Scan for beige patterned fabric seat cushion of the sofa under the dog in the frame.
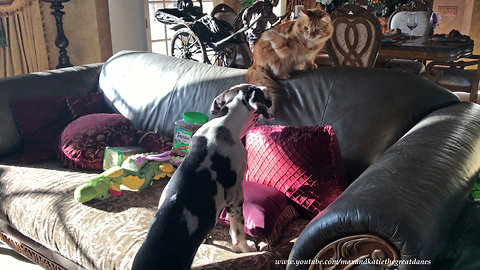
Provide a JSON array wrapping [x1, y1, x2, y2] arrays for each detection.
[[0, 161, 308, 269]]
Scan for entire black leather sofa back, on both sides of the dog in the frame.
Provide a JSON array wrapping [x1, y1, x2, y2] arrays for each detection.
[[100, 51, 458, 182]]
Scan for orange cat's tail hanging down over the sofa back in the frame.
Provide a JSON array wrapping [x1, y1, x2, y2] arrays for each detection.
[[245, 64, 284, 115]]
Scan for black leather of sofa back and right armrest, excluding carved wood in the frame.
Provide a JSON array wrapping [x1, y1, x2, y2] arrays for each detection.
[[100, 52, 480, 269]]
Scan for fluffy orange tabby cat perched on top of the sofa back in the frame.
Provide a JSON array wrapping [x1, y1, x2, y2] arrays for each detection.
[[245, 9, 333, 109]]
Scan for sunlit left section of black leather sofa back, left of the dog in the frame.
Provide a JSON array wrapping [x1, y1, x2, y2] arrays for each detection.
[[100, 51, 245, 136]]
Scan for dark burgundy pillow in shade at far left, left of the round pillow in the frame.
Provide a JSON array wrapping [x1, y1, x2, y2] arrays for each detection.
[[10, 97, 70, 163]]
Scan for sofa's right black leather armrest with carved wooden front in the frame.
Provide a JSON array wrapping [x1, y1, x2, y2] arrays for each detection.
[[287, 103, 480, 269]]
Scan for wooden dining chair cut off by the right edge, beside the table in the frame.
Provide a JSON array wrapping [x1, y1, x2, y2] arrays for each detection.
[[426, 55, 480, 103]]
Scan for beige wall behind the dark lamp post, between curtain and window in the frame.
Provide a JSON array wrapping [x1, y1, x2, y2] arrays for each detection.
[[41, 0, 112, 69]]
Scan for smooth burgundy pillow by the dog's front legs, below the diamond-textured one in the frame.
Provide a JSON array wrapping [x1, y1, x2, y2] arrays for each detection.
[[217, 181, 298, 246]]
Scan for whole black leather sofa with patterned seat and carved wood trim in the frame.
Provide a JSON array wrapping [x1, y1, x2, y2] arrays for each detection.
[[0, 51, 480, 269]]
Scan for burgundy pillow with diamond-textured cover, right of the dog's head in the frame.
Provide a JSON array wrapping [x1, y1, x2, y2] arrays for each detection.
[[245, 126, 346, 218]]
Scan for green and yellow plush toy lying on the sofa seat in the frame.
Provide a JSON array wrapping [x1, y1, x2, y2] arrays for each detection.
[[74, 151, 175, 203]]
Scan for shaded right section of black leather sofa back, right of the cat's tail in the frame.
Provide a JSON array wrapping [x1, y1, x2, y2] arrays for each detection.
[[273, 68, 458, 182]]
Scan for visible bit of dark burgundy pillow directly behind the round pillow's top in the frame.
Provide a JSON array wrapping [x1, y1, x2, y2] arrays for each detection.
[[66, 92, 105, 119]]
